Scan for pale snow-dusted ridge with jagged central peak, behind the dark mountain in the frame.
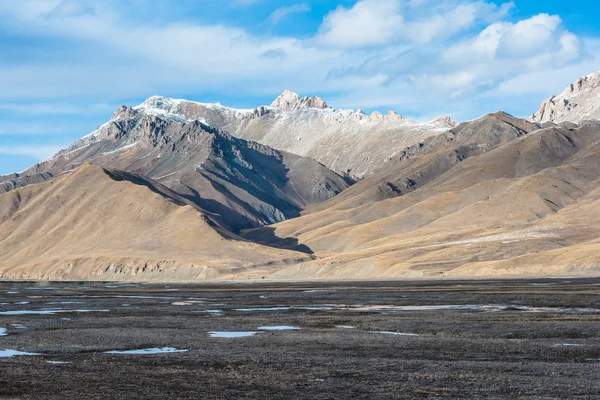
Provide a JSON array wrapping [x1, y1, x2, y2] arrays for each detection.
[[126, 91, 456, 178]]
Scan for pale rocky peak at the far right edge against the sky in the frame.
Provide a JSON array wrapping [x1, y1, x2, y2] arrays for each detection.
[[531, 72, 600, 123]]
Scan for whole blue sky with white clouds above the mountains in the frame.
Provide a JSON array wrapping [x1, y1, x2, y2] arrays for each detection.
[[0, 0, 600, 174]]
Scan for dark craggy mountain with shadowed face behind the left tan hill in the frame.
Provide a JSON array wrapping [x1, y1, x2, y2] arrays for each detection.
[[2, 107, 351, 232]]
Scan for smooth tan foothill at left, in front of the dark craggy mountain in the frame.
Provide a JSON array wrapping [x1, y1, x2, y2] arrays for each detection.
[[0, 164, 310, 281]]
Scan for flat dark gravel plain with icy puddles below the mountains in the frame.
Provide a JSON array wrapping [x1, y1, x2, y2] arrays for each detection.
[[0, 278, 600, 399]]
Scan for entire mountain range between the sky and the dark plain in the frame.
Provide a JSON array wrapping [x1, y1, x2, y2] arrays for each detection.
[[0, 73, 600, 280]]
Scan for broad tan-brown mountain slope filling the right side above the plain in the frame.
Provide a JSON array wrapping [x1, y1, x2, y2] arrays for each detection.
[[247, 114, 600, 279]]
